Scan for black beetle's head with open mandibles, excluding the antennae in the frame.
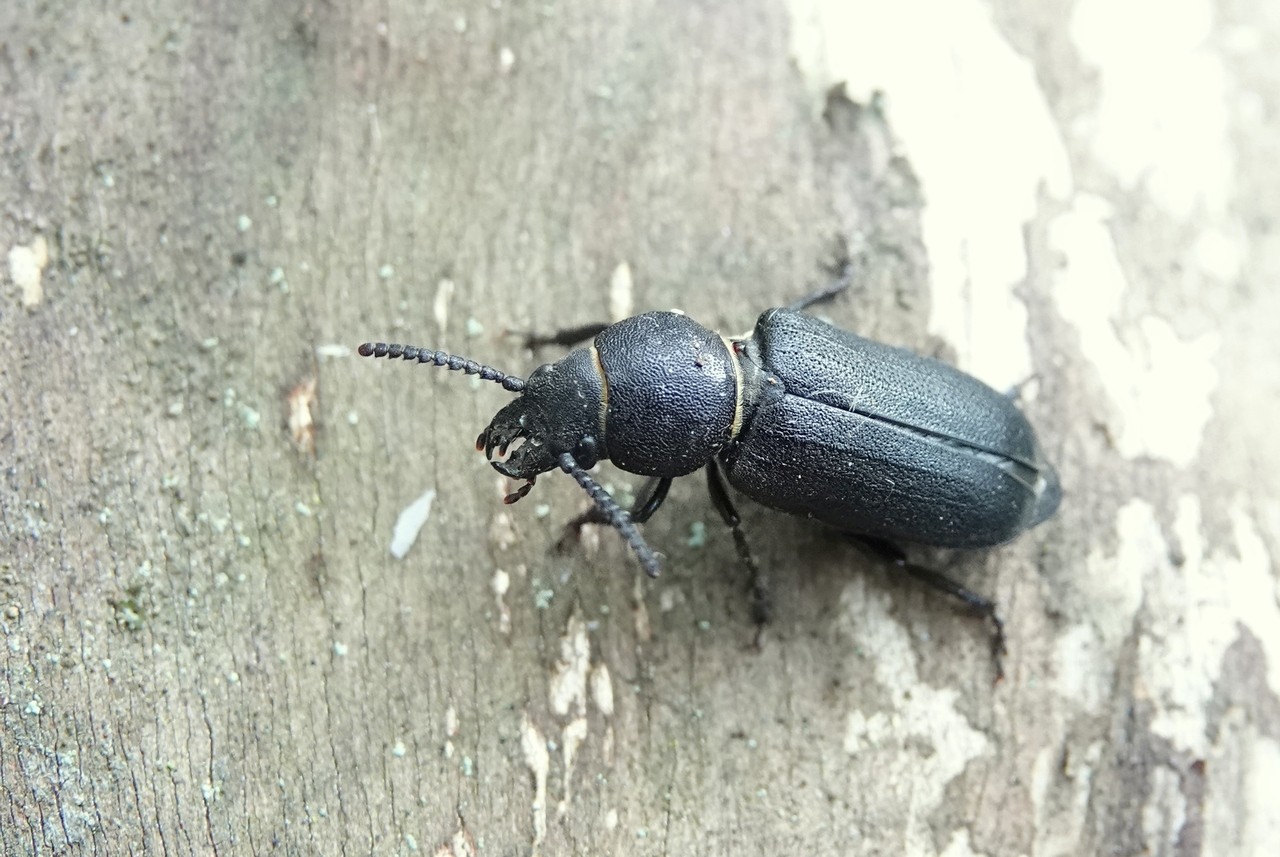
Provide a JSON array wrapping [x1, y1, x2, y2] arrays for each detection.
[[476, 349, 603, 483]]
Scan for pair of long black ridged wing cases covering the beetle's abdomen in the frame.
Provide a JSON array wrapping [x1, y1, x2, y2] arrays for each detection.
[[723, 310, 1061, 547]]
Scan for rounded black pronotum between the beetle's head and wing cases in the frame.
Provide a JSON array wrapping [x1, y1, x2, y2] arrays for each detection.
[[595, 312, 739, 476]]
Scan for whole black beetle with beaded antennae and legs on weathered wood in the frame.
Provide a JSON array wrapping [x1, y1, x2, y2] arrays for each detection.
[[358, 267, 1061, 673]]
